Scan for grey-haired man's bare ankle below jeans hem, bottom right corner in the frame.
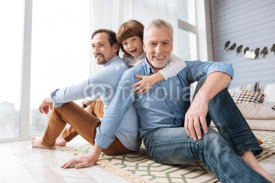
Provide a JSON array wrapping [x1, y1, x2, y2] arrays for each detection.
[[241, 151, 275, 183]]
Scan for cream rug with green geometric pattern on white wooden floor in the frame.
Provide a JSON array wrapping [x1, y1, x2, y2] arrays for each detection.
[[62, 133, 275, 183]]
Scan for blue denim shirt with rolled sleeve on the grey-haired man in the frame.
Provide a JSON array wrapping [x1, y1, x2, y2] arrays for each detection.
[[96, 58, 234, 148]]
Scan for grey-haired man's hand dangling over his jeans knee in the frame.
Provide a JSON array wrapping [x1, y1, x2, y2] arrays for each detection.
[[184, 95, 208, 141]]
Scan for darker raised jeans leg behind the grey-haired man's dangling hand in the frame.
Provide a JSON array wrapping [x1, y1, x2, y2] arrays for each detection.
[[194, 76, 263, 156]]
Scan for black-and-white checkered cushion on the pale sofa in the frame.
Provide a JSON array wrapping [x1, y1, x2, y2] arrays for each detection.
[[229, 90, 265, 104]]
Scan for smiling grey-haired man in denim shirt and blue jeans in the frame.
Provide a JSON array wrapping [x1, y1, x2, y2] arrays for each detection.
[[63, 20, 274, 182]]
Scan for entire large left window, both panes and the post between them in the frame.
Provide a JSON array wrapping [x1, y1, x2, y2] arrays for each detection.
[[0, 0, 91, 142]]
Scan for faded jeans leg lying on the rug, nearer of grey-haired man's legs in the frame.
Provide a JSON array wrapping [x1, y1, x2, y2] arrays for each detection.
[[144, 127, 269, 183]]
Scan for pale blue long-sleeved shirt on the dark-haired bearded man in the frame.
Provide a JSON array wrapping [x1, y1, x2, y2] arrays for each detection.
[[51, 56, 141, 151]]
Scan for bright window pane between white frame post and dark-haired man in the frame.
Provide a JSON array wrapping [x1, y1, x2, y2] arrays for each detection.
[[30, 0, 90, 136]]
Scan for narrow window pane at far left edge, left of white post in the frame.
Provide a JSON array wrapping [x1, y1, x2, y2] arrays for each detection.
[[0, 0, 25, 138]]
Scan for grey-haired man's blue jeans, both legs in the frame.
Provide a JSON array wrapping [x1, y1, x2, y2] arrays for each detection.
[[144, 77, 269, 183]]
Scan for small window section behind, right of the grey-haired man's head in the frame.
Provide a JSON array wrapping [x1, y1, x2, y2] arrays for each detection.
[[178, 0, 198, 61]]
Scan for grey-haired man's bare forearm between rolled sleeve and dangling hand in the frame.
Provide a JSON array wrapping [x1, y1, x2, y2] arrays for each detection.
[[196, 72, 231, 101]]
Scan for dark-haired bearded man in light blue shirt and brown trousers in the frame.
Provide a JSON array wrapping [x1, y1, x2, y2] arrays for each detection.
[[32, 29, 141, 159]]
